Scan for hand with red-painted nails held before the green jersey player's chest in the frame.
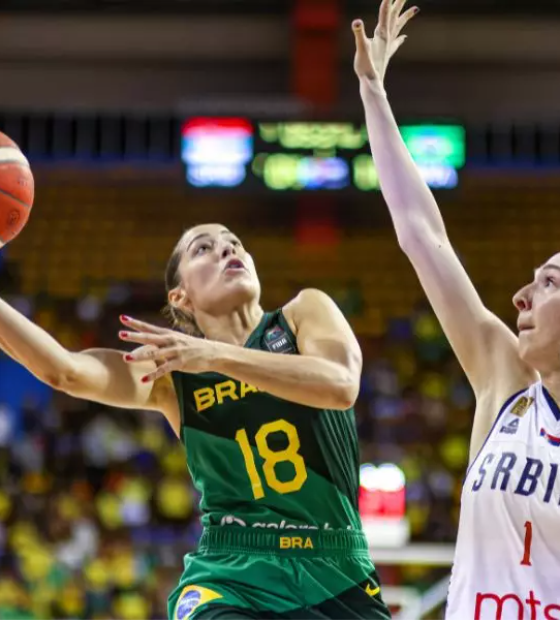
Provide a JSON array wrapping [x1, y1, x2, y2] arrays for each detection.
[[119, 316, 218, 383]]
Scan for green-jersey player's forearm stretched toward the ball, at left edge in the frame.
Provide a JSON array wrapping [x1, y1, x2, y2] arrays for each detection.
[[0, 299, 72, 385]]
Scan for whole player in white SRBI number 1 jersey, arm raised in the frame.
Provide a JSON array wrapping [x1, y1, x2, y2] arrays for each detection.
[[353, 0, 560, 620]]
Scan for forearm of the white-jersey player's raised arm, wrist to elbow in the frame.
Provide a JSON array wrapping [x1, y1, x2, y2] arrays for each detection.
[[360, 78, 446, 246]]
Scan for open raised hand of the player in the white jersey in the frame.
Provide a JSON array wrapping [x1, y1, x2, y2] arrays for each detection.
[[352, 0, 420, 86]]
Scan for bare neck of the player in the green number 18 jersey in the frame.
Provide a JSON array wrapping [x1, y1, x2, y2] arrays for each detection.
[[196, 303, 264, 347]]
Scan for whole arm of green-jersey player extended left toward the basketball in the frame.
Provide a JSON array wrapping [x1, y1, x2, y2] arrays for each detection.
[[0, 299, 179, 432]]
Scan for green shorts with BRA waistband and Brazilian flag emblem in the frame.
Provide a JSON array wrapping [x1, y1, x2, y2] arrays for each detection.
[[168, 526, 391, 620]]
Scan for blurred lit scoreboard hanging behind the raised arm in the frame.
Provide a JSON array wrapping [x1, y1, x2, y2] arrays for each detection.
[[182, 118, 465, 192]]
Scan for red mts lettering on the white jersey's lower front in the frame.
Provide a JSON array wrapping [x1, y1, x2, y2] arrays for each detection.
[[474, 590, 560, 620]]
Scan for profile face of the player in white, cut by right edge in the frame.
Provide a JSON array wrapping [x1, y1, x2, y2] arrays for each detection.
[[513, 254, 560, 372]]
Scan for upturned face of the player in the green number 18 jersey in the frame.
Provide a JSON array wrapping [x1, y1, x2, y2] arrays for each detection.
[[173, 224, 260, 315]]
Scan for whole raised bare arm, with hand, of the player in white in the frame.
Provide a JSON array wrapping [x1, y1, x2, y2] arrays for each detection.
[[353, 0, 536, 450]]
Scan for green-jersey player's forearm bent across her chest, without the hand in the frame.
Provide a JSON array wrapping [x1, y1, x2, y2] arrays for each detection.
[[212, 344, 358, 410]]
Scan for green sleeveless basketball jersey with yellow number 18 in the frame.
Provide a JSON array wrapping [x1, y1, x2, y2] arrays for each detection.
[[173, 310, 361, 530]]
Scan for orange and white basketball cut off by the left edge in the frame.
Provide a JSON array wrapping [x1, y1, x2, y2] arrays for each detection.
[[0, 132, 35, 247]]
